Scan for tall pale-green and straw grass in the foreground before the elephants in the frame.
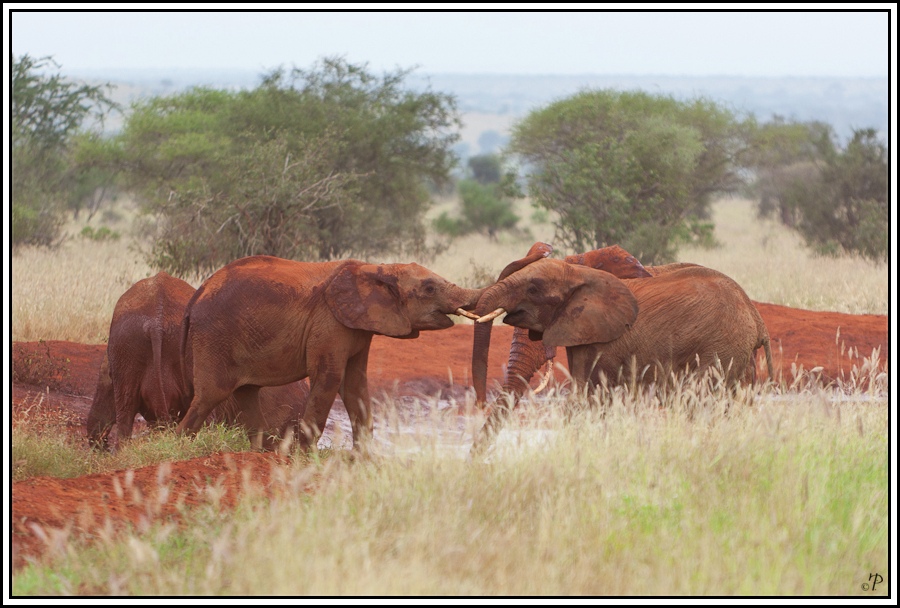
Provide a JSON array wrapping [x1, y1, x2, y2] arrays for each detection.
[[13, 389, 888, 596]]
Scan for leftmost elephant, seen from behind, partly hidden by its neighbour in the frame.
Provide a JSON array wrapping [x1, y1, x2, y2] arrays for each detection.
[[87, 272, 309, 450]]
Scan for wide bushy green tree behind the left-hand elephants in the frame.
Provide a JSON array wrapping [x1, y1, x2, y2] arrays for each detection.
[[90, 59, 459, 275]]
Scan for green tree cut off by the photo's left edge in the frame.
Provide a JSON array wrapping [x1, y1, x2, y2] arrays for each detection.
[[11, 54, 116, 247]]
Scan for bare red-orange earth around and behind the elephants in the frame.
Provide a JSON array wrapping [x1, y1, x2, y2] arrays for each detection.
[[10, 304, 888, 569]]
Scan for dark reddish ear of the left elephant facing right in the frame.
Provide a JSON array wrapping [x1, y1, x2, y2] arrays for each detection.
[[325, 264, 413, 338]]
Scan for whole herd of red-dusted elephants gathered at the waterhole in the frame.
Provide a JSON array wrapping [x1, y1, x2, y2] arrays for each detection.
[[87, 243, 774, 450]]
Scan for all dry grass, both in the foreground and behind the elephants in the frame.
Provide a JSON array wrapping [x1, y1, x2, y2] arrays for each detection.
[[12, 200, 890, 597]]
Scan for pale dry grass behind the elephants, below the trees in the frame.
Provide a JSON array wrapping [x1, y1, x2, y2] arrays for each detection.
[[12, 199, 888, 344]]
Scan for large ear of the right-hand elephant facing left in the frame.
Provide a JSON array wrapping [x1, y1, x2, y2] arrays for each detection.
[[543, 268, 638, 347]]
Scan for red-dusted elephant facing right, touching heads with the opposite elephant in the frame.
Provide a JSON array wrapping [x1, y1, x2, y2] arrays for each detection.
[[177, 255, 482, 449]]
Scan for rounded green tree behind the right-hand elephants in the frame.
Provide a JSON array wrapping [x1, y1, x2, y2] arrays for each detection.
[[509, 90, 742, 263]]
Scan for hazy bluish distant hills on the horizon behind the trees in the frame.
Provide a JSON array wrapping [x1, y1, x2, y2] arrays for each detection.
[[69, 69, 888, 157]]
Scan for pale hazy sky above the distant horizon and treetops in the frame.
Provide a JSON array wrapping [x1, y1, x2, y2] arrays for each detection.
[[4, 3, 896, 76]]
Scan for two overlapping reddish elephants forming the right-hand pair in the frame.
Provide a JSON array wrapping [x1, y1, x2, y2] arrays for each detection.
[[472, 243, 774, 452]]
